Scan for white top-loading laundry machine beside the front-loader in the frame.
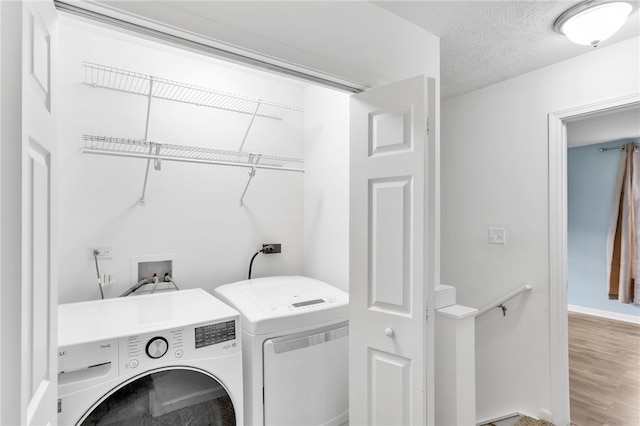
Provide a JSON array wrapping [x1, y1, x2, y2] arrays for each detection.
[[214, 276, 349, 426]]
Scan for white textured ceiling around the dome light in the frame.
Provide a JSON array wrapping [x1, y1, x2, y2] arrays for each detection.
[[374, 0, 640, 98]]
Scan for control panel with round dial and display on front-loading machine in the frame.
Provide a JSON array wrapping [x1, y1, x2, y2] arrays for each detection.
[[119, 319, 240, 374]]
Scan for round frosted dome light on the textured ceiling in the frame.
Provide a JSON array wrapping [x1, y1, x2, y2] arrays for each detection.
[[553, 0, 635, 47]]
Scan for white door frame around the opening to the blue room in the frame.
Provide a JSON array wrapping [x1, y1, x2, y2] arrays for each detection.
[[548, 92, 640, 425]]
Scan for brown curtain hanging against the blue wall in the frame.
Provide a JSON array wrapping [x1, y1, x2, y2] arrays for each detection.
[[607, 143, 640, 305]]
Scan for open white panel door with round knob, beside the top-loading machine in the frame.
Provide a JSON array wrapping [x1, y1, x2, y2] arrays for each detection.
[[349, 77, 437, 425]]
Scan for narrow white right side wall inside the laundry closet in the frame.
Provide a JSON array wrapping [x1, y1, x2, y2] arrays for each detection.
[[304, 87, 349, 291]]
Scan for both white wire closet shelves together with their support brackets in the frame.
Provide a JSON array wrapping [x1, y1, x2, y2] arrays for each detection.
[[82, 62, 304, 206]]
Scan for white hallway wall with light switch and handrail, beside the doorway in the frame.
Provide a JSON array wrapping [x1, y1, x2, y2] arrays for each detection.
[[441, 38, 640, 420]]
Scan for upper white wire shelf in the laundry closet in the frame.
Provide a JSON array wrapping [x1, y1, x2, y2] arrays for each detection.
[[82, 62, 303, 120]]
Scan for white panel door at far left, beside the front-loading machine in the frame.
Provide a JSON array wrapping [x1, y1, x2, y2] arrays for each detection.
[[0, 0, 57, 425]]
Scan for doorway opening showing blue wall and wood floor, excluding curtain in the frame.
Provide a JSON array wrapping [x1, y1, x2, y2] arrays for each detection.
[[567, 108, 640, 426]]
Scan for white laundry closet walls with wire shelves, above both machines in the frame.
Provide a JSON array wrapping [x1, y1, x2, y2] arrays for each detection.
[[57, 16, 349, 303]]
